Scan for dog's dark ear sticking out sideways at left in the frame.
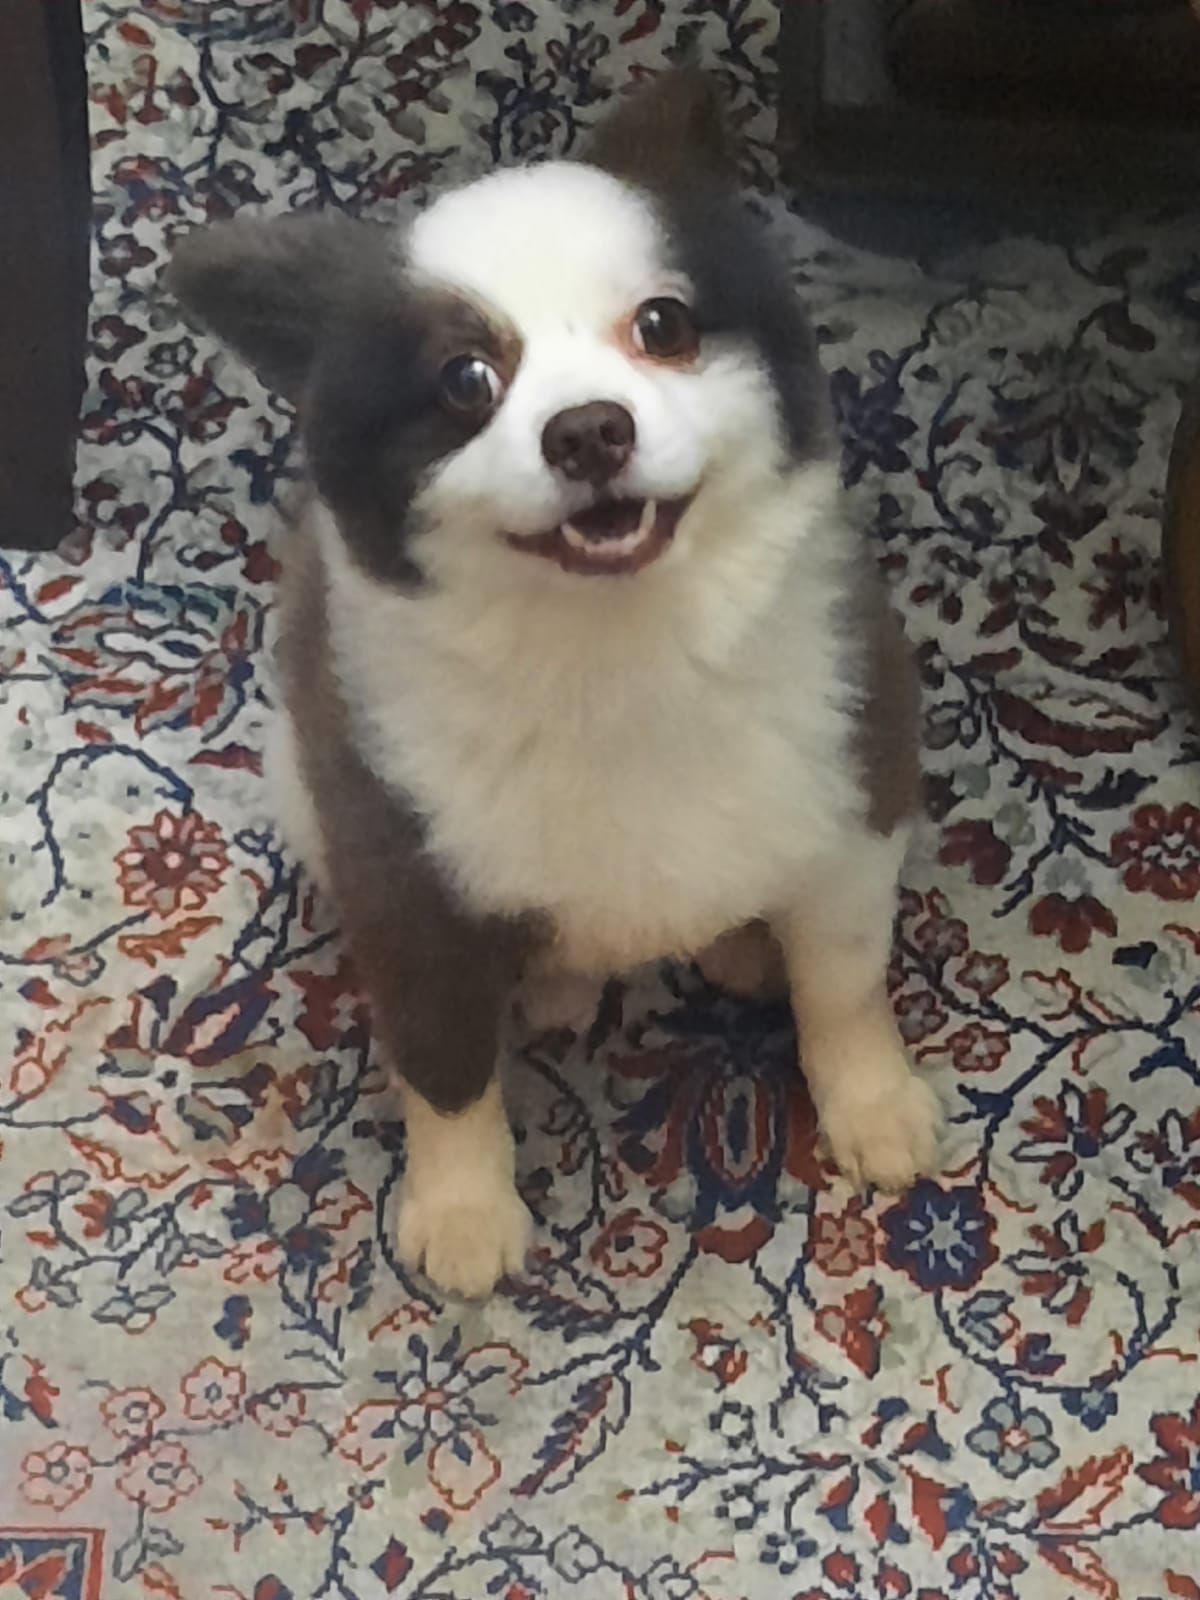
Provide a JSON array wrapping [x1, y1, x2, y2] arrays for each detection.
[[166, 214, 402, 402]]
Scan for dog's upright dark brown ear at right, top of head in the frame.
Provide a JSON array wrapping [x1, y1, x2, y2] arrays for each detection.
[[582, 66, 738, 187]]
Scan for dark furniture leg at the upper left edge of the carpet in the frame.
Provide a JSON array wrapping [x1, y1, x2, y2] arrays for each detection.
[[0, 0, 91, 550]]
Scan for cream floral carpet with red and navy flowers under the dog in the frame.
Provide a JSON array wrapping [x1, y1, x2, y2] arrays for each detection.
[[0, 0, 1200, 1600]]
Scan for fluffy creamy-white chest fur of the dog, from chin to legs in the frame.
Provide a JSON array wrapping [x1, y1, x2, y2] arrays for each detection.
[[322, 470, 861, 971]]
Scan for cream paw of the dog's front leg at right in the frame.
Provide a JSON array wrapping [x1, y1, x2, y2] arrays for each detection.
[[821, 1070, 941, 1192]]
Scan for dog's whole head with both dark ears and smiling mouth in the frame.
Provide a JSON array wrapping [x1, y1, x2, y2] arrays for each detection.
[[171, 74, 829, 587]]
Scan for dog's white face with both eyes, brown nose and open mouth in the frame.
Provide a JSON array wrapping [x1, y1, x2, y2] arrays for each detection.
[[408, 163, 739, 576]]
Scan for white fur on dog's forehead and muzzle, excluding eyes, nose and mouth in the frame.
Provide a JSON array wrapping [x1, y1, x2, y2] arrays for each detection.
[[410, 163, 782, 586]]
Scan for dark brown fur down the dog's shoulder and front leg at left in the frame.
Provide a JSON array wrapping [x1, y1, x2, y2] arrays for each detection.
[[278, 528, 538, 1112]]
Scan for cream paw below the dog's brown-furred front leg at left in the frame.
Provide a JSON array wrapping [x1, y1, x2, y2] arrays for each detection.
[[397, 1179, 533, 1299]]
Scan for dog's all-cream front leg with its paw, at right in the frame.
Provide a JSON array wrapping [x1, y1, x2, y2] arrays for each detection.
[[776, 832, 938, 1189]]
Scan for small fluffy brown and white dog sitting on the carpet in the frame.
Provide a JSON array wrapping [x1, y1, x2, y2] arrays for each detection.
[[173, 72, 936, 1294]]
